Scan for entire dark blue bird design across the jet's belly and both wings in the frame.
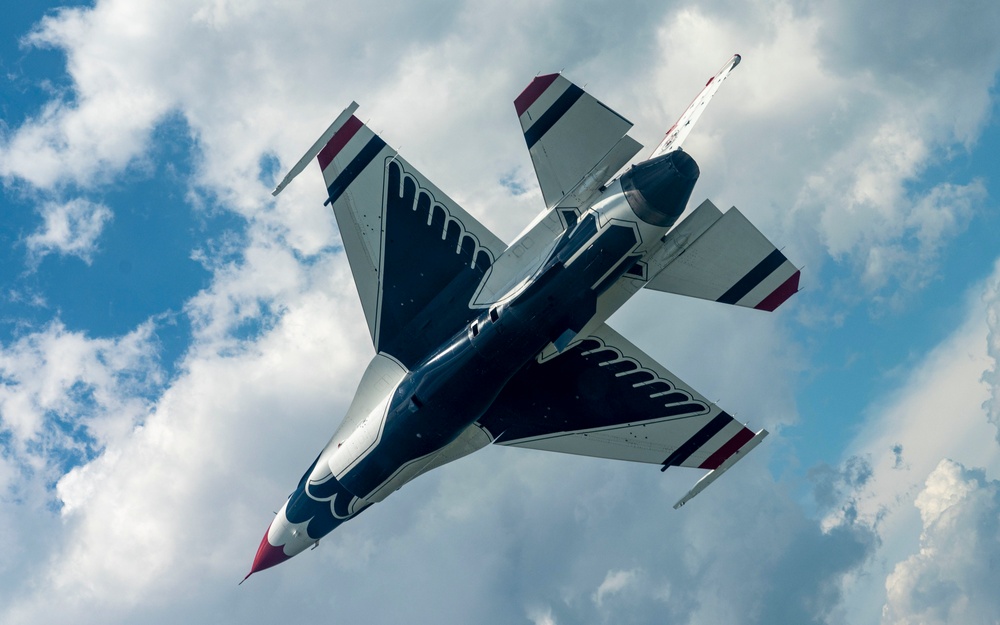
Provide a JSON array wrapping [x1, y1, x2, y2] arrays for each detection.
[[289, 147, 708, 539]]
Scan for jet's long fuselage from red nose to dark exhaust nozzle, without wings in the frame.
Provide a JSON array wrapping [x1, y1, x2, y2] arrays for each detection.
[[251, 151, 698, 572]]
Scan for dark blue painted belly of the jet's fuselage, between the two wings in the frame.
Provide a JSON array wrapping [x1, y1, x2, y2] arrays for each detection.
[[340, 210, 648, 498]]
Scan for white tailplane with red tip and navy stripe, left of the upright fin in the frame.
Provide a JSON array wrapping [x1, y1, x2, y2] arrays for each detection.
[[514, 74, 642, 208]]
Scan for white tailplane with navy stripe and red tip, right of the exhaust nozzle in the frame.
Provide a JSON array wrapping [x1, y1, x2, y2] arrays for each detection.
[[646, 200, 799, 311]]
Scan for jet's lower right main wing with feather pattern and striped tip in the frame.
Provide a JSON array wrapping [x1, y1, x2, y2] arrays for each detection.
[[479, 325, 763, 469]]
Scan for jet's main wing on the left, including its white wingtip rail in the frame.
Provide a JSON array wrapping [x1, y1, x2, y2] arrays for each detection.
[[275, 104, 506, 368]]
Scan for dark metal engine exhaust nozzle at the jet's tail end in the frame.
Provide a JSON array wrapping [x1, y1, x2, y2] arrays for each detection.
[[621, 150, 701, 228]]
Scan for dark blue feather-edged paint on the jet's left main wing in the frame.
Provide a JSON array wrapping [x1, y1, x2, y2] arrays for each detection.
[[376, 161, 492, 369]]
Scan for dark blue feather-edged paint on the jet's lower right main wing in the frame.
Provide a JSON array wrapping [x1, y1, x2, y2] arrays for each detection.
[[479, 338, 709, 443]]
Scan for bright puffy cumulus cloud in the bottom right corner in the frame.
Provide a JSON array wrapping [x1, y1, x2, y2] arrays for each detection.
[[882, 460, 1000, 625]]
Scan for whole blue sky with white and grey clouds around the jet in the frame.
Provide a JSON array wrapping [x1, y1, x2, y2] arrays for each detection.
[[0, 0, 1000, 625]]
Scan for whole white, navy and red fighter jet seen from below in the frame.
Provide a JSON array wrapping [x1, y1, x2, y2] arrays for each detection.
[[244, 55, 799, 579]]
